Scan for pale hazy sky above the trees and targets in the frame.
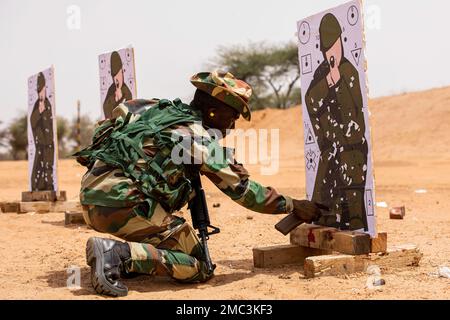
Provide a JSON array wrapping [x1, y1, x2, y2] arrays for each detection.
[[0, 0, 450, 123]]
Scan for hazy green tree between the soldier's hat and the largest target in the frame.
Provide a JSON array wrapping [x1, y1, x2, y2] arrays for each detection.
[[212, 42, 301, 109]]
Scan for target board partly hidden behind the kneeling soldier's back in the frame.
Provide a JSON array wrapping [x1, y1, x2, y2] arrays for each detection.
[[98, 47, 137, 119]]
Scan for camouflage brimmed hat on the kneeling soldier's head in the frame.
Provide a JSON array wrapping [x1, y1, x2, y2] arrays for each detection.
[[191, 71, 252, 121]]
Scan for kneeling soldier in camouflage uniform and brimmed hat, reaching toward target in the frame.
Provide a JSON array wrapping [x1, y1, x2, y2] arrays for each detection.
[[76, 72, 321, 296]]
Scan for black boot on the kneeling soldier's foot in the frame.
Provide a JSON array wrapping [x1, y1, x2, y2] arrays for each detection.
[[86, 238, 131, 297]]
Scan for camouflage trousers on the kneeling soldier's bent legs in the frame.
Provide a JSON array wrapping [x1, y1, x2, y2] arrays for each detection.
[[83, 203, 212, 283]]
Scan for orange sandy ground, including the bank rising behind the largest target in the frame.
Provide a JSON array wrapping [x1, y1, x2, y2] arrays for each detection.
[[0, 88, 450, 300]]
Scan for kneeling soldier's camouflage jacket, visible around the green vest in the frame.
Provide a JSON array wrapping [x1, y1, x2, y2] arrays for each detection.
[[80, 104, 293, 216]]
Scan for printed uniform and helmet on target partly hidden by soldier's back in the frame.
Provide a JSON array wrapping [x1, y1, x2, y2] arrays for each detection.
[[103, 51, 133, 119]]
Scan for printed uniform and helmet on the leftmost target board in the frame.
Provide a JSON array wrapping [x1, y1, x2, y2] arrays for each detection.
[[30, 73, 55, 191]]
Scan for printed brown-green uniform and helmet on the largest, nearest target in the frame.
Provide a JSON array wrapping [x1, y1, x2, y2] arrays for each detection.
[[305, 14, 368, 231]]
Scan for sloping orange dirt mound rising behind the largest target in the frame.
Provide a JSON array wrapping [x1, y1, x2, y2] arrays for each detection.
[[238, 87, 450, 161]]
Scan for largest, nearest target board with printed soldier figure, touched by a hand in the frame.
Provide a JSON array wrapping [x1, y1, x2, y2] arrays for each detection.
[[298, 1, 376, 235]]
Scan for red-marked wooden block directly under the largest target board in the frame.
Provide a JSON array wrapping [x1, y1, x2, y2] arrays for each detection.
[[291, 224, 371, 255]]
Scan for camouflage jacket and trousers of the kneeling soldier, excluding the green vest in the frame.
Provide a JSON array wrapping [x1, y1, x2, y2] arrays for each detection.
[[80, 72, 293, 282]]
